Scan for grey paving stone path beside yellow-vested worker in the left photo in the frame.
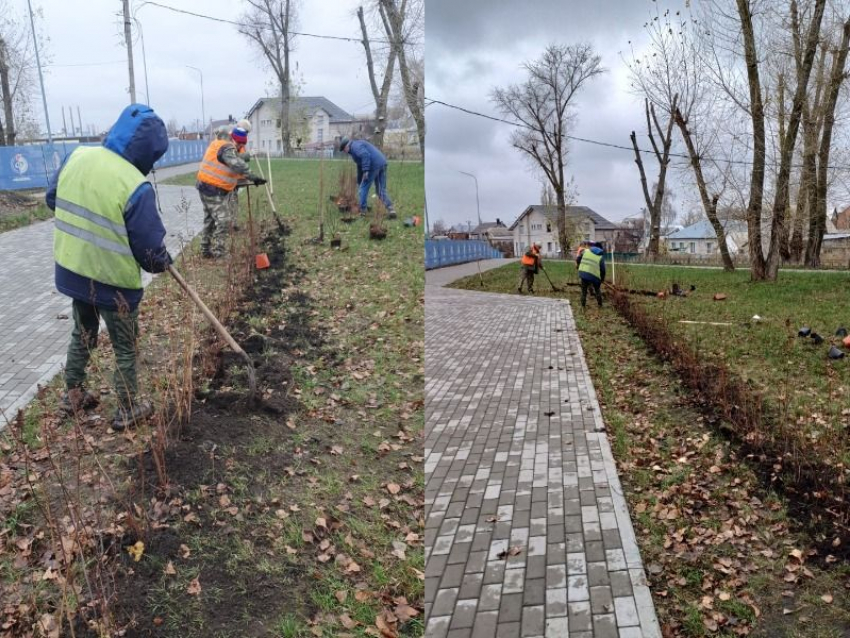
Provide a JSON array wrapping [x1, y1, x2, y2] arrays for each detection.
[[0, 164, 203, 429]]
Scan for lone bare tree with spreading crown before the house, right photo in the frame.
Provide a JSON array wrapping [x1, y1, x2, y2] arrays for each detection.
[[491, 43, 605, 256]]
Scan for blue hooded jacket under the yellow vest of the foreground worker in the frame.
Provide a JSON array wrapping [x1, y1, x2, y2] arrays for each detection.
[[45, 104, 171, 310]]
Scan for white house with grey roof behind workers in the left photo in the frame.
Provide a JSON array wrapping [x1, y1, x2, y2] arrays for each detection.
[[245, 97, 366, 155]]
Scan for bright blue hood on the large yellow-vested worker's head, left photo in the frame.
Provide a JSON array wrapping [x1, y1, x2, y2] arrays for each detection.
[[103, 104, 168, 175]]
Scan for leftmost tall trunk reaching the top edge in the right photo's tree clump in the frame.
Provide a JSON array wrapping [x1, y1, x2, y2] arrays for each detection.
[[736, 0, 766, 281]]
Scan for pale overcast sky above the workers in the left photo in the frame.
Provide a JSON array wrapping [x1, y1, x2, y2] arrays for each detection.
[[19, 0, 374, 133]]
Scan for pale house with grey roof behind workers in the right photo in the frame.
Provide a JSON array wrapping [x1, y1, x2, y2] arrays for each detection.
[[508, 204, 621, 257]]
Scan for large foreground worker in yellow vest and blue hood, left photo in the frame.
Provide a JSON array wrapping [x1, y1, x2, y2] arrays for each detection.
[[46, 104, 171, 430]]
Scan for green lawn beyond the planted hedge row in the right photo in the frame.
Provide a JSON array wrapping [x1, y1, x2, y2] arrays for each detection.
[[454, 261, 850, 450]]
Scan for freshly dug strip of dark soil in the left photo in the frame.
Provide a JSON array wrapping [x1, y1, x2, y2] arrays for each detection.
[[107, 228, 330, 638]]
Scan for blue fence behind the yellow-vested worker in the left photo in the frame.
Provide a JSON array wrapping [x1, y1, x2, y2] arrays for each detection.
[[0, 140, 207, 191]]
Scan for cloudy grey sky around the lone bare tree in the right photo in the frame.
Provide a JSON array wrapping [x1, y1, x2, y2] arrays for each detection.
[[425, 0, 679, 230]]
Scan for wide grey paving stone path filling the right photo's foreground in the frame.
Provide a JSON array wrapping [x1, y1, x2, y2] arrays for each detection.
[[425, 261, 661, 638]]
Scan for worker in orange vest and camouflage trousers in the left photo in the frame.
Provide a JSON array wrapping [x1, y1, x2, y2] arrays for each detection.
[[197, 126, 266, 259]]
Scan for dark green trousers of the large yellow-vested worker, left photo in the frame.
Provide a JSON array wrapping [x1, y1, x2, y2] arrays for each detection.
[[65, 299, 139, 407]]
